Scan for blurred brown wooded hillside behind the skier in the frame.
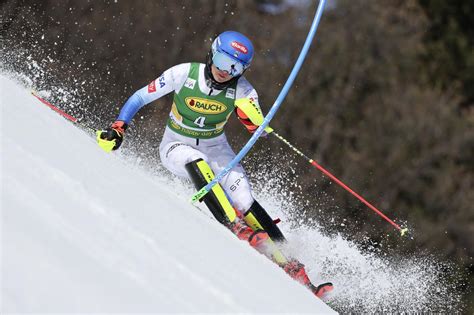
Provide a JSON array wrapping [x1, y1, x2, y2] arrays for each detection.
[[0, 0, 474, 313]]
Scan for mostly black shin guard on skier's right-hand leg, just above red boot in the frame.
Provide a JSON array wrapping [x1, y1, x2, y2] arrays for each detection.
[[244, 200, 286, 242]]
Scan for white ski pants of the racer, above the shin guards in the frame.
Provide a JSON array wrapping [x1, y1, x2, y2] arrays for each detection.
[[160, 127, 254, 212]]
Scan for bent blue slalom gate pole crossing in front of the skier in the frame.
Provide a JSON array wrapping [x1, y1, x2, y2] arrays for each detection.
[[191, 0, 326, 202]]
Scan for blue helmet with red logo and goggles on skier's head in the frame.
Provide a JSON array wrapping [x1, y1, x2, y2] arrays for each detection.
[[206, 31, 254, 88]]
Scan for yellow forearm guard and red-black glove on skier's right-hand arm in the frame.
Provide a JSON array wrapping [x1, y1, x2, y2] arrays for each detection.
[[235, 98, 273, 137]]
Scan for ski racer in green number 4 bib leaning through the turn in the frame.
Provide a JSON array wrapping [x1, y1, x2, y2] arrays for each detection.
[[97, 31, 332, 297]]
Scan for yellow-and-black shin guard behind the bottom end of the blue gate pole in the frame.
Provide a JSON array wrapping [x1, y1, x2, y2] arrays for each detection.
[[185, 159, 237, 226]]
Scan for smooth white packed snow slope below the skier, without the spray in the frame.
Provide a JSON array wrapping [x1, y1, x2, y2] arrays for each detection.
[[0, 76, 334, 314]]
